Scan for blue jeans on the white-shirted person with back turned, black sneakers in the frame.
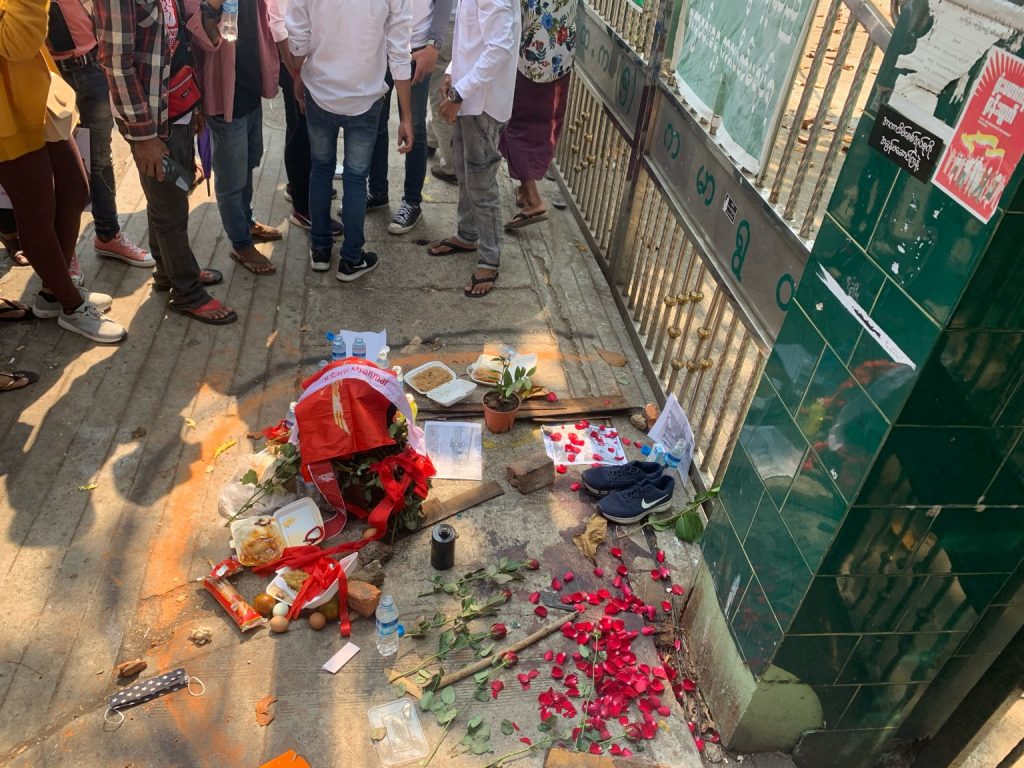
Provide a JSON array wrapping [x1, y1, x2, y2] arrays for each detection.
[[306, 88, 381, 264]]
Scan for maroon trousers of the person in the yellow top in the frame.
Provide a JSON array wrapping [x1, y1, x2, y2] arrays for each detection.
[[0, 141, 89, 312]]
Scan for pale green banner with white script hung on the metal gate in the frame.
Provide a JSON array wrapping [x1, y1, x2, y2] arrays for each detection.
[[676, 0, 815, 172]]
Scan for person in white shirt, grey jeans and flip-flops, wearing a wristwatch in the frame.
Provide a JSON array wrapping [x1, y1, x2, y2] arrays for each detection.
[[428, 0, 522, 298]]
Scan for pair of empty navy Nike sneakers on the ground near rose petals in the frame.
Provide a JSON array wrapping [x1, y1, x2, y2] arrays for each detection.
[[583, 462, 676, 525]]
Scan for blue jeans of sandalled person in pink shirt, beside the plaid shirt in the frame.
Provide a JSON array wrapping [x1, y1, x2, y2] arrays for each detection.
[[206, 104, 263, 250]]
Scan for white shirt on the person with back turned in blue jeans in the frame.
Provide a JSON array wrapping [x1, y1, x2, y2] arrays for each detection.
[[285, 0, 413, 116]]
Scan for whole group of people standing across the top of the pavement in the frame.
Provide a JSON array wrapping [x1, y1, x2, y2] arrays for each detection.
[[0, 0, 575, 391]]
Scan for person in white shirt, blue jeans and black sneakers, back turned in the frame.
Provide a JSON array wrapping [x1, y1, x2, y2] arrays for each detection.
[[285, 0, 413, 283]]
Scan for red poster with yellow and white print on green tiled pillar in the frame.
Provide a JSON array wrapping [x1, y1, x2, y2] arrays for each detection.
[[932, 48, 1024, 222]]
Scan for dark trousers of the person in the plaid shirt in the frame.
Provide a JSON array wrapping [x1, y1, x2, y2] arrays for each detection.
[[138, 123, 210, 309]]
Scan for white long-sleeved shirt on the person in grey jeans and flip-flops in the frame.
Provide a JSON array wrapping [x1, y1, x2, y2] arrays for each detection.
[[447, 0, 522, 123]]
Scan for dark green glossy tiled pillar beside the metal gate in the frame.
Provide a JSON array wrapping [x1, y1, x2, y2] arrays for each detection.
[[703, 4, 1024, 768]]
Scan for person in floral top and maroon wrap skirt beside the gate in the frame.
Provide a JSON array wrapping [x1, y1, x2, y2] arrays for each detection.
[[499, 0, 577, 229]]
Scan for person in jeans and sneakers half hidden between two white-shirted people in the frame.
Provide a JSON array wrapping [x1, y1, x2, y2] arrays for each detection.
[[367, 0, 453, 234]]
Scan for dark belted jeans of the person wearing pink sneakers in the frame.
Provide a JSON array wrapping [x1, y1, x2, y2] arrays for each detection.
[[60, 59, 121, 241]]
